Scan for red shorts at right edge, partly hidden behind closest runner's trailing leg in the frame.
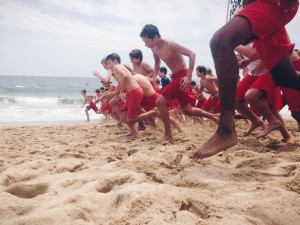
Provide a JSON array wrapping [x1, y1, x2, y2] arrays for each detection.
[[280, 59, 300, 112]]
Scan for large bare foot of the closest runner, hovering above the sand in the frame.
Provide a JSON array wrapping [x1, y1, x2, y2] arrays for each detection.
[[190, 130, 238, 160]]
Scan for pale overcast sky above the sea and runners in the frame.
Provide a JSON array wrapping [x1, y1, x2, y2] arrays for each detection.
[[0, 0, 300, 77]]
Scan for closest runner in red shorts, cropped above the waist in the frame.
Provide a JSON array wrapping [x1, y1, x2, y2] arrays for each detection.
[[191, 0, 300, 159]]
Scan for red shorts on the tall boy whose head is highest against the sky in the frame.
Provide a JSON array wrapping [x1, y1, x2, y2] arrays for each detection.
[[161, 68, 193, 108]]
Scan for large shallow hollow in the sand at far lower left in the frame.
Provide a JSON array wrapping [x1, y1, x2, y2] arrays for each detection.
[[4, 183, 49, 198]]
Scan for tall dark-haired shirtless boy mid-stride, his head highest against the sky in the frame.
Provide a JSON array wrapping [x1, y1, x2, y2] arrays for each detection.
[[140, 24, 218, 140]]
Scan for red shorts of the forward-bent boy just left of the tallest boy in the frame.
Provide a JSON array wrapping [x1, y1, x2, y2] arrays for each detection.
[[123, 87, 144, 119]]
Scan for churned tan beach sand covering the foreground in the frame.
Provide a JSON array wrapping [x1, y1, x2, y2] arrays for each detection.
[[0, 119, 300, 225]]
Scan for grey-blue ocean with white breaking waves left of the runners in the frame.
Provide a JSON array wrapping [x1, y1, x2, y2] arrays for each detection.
[[0, 76, 102, 124]]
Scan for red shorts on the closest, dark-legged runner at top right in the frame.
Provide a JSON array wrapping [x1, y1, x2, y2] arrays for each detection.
[[238, 0, 299, 71]]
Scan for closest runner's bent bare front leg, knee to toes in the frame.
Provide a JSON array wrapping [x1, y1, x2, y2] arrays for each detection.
[[191, 16, 254, 159]]
